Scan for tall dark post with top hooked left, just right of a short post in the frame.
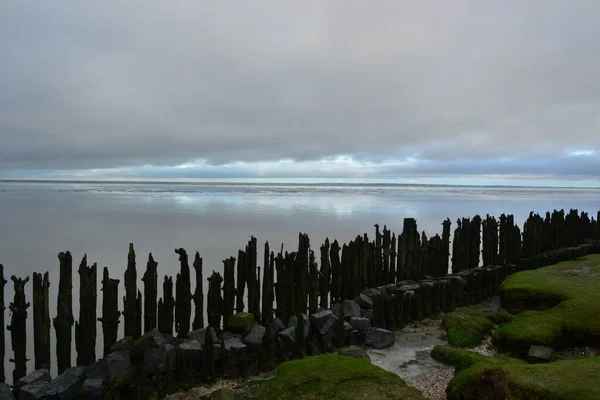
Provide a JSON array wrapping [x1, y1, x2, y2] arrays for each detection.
[[175, 248, 192, 338]]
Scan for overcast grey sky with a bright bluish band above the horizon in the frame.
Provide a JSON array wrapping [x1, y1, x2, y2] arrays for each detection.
[[0, 0, 600, 186]]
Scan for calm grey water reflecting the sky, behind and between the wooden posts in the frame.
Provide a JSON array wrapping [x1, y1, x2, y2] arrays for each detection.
[[0, 182, 600, 381]]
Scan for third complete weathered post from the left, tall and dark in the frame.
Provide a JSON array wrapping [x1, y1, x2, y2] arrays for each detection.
[[53, 251, 75, 374]]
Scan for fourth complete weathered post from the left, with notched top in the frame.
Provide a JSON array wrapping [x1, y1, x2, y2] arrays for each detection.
[[75, 255, 98, 366]]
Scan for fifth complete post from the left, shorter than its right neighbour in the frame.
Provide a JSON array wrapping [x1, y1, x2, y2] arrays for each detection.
[[98, 267, 121, 355]]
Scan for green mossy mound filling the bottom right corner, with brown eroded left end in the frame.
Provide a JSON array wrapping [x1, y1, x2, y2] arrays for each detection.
[[431, 346, 600, 400]]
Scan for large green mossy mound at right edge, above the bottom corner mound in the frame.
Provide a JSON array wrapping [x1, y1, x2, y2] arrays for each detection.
[[493, 254, 600, 356]]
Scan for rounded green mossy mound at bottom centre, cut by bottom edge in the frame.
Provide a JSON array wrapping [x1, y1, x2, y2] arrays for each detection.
[[255, 354, 424, 400]]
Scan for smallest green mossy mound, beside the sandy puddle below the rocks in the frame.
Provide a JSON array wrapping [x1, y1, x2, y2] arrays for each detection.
[[442, 308, 512, 347]]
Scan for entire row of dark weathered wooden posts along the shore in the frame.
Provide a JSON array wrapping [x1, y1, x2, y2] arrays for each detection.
[[0, 210, 600, 382]]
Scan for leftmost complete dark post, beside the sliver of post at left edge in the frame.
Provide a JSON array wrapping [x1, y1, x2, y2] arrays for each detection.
[[7, 275, 30, 382]]
